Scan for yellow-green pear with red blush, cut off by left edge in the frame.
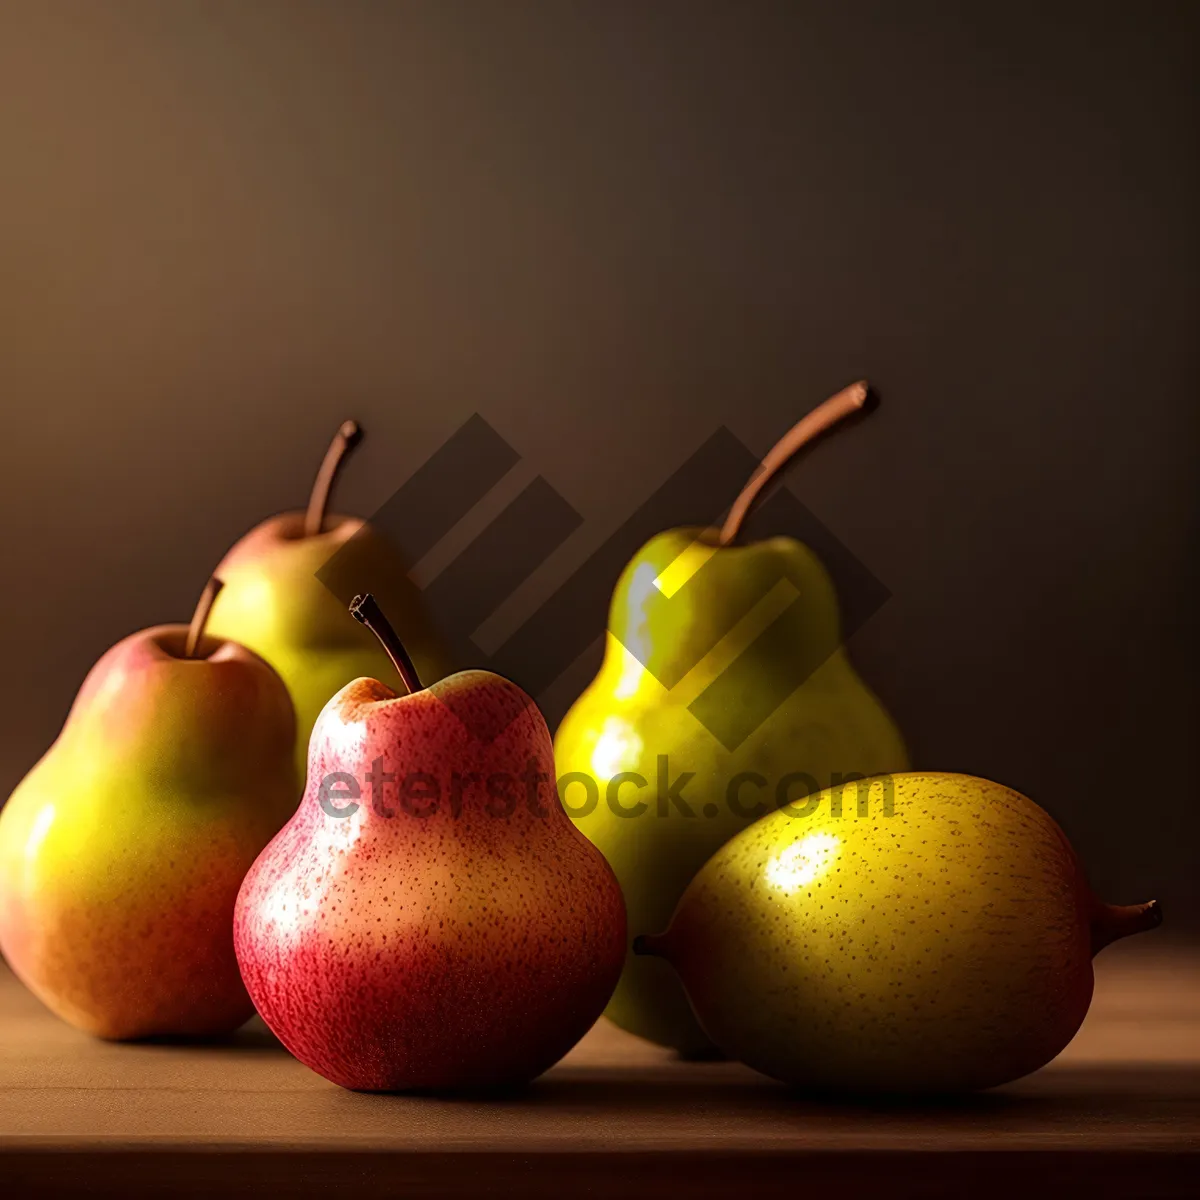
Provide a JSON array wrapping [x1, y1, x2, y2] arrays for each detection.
[[0, 581, 296, 1039]]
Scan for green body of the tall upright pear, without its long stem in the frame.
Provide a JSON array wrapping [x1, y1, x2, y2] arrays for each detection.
[[554, 528, 908, 1055]]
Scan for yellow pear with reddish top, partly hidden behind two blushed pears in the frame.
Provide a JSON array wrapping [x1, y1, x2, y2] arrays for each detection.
[[209, 421, 452, 780]]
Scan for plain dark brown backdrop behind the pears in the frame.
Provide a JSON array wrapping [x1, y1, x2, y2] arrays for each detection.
[[0, 0, 1200, 928]]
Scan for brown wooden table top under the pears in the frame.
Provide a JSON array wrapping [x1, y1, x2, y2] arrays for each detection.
[[0, 940, 1200, 1200]]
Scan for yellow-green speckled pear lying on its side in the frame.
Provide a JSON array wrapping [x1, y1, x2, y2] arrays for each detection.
[[635, 774, 1162, 1094]]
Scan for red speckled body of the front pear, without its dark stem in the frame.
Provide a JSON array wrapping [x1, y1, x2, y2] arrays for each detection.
[[234, 671, 625, 1091]]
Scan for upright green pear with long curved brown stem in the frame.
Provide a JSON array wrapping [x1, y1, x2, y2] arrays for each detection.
[[554, 383, 908, 1056]]
